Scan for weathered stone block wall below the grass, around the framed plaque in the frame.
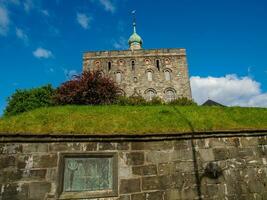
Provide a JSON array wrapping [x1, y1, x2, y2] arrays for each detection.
[[0, 136, 267, 200]]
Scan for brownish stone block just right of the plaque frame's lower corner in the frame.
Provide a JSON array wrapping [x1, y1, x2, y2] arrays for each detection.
[[120, 179, 141, 194]]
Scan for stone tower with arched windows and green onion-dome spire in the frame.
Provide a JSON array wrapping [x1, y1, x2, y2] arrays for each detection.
[[83, 12, 192, 101]]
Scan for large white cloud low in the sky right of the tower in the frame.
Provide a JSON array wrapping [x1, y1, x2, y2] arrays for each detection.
[[190, 74, 267, 107]]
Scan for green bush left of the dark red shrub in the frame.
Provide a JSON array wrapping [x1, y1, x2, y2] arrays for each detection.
[[4, 84, 54, 116]]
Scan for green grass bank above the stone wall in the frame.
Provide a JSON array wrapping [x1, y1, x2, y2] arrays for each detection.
[[0, 105, 267, 135]]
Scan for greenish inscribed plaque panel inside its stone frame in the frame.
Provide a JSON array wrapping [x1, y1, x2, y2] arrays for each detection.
[[63, 157, 113, 192]]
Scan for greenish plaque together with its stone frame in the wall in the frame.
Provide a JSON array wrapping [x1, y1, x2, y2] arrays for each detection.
[[58, 153, 118, 199]]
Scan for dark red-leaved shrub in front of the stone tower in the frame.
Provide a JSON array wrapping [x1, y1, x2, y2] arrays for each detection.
[[55, 71, 119, 105]]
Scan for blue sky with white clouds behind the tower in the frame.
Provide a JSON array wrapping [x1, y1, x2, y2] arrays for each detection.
[[0, 0, 267, 114]]
